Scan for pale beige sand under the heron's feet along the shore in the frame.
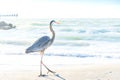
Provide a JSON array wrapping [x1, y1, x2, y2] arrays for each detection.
[[0, 64, 120, 80]]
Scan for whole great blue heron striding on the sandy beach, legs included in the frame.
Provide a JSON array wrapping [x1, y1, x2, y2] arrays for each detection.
[[26, 20, 58, 76]]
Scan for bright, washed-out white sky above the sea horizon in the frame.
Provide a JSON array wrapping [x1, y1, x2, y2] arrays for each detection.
[[0, 0, 120, 18]]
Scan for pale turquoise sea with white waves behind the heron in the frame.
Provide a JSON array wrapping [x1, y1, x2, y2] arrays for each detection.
[[0, 18, 120, 58]]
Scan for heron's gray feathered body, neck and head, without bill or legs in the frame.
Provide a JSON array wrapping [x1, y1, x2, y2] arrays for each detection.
[[25, 20, 55, 53]]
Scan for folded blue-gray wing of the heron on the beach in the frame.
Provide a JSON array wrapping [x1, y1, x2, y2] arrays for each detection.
[[26, 36, 50, 53]]
